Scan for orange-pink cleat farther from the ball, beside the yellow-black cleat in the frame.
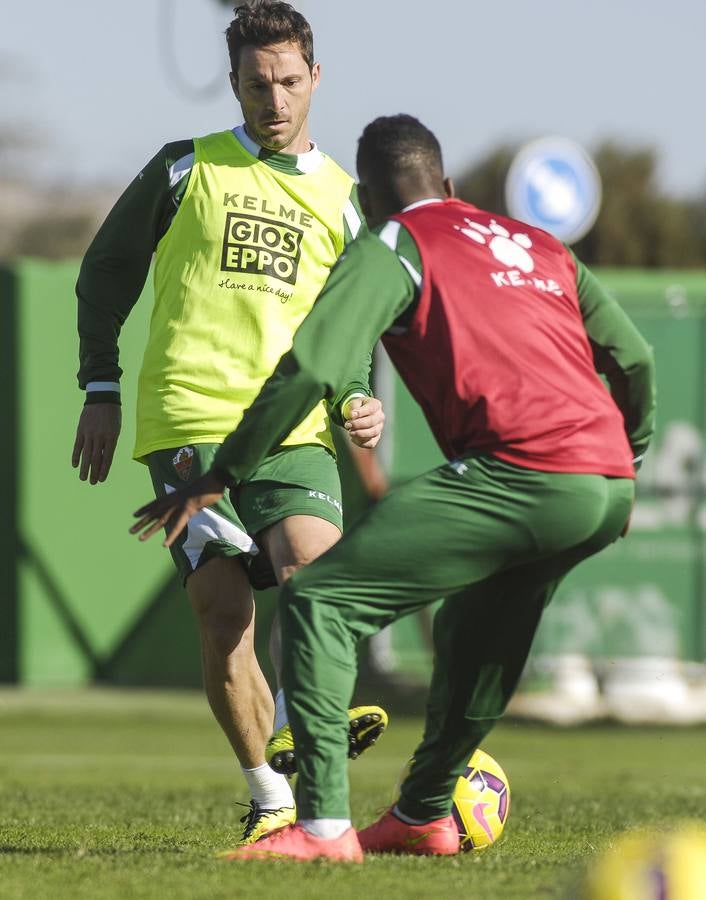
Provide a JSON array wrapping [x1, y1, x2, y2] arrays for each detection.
[[219, 824, 363, 863]]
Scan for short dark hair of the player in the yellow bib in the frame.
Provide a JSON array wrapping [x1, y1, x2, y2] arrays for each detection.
[[226, 0, 314, 75]]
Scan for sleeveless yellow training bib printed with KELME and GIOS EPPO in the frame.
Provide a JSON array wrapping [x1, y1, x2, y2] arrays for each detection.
[[134, 131, 353, 458]]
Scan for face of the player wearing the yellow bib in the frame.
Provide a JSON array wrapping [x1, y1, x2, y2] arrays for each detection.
[[230, 42, 319, 153]]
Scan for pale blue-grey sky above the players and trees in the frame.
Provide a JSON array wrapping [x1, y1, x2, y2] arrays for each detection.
[[0, 0, 706, 196]]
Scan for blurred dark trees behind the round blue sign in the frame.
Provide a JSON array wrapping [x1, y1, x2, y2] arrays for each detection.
[[456, 141, 706, 268]]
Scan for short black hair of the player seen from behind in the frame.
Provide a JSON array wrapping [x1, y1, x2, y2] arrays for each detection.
[[357, 113, 444, 177]]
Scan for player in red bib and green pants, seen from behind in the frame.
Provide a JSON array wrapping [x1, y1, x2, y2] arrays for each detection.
[[132, 116, 654, 861]]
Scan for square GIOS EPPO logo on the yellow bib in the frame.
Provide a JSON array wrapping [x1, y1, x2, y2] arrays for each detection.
[[221, 212, 304, 284]]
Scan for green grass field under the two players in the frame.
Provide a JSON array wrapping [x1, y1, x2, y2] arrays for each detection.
[[0, 691, 706, 900]]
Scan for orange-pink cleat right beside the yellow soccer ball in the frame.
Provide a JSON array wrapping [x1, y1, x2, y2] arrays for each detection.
[[358, 809, 459, 856]]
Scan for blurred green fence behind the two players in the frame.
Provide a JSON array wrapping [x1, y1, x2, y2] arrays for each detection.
[[0, 261, 706, 686]]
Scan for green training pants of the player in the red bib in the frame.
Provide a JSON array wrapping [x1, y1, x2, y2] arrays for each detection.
[[280, 455, 634, 821]]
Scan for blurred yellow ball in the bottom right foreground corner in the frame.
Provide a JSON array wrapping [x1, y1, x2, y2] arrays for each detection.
[[583, 823, 706, 900]]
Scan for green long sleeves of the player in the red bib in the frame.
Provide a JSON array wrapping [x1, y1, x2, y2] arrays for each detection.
[[215, 205, 655, 482]]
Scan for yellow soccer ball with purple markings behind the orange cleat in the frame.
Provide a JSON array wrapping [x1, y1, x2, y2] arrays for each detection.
[[451, 750, 510, 851]]
